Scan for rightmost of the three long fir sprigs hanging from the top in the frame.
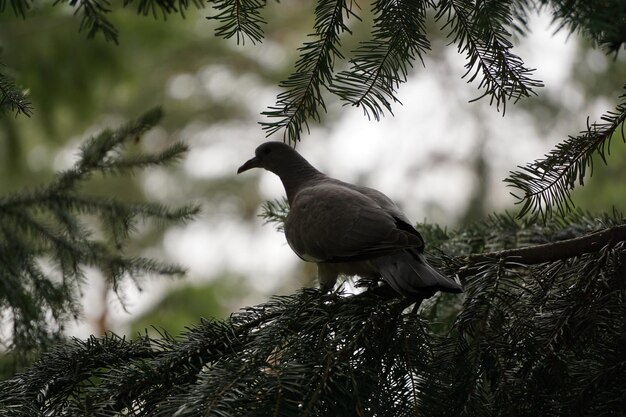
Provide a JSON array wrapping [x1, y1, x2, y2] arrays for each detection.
[[436, 0, 543, 111]]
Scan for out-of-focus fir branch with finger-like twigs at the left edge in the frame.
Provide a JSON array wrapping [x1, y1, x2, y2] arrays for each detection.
[[0, 110, 198, 360]]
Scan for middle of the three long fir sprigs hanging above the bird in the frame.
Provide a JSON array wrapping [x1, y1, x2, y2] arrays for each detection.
[[331, 0, 431, 120]]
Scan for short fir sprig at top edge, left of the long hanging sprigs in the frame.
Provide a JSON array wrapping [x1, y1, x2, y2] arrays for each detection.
[[207, 0, 267, 44]]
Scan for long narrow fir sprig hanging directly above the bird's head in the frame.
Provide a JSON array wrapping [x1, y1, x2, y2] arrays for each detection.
[[261, 0, 356, 143]]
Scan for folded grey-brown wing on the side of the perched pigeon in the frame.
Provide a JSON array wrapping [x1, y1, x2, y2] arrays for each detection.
[[285, 181, 424, 262]]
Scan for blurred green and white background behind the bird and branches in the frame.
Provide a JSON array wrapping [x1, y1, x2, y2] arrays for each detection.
[[0, 0, 626, 337]]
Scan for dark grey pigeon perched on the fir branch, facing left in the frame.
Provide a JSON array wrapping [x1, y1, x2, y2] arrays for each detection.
[[237, 141, 463, 300]]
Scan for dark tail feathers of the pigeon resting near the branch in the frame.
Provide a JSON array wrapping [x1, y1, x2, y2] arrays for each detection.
[[374, 250, 463, 298]]
